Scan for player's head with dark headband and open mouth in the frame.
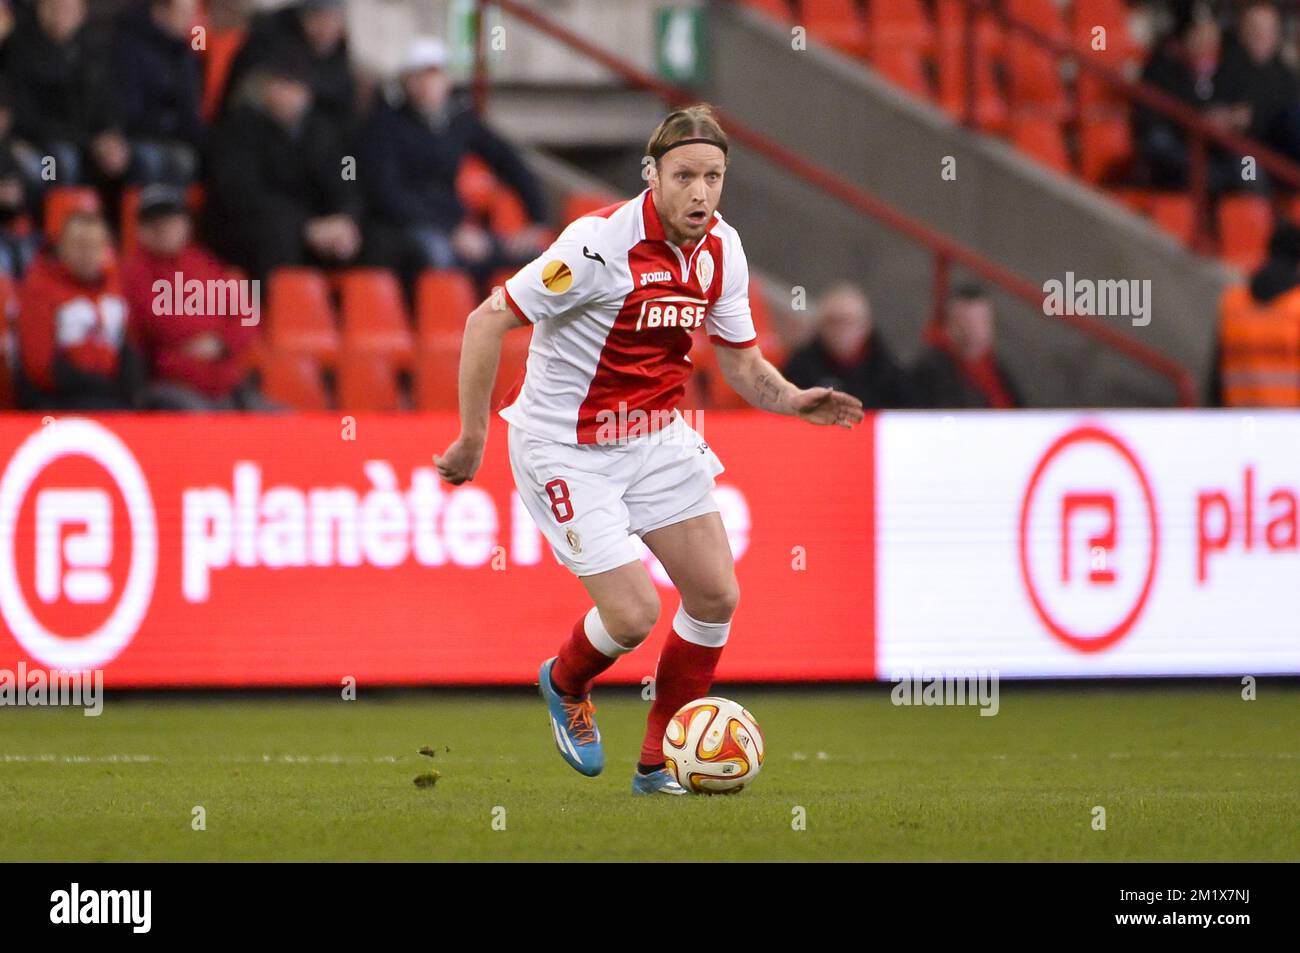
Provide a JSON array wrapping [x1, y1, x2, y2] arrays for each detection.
[[645, 103, 728, 244]]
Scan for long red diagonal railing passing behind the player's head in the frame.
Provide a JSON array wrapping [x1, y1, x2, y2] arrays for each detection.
[[475, 0, 1196, 407]]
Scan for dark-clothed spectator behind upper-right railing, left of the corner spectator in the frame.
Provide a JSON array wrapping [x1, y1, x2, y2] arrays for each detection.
[[1134, 4, 1260, 192]]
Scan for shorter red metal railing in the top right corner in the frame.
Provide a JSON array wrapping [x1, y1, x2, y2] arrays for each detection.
[[961, 0, 1300, 252]]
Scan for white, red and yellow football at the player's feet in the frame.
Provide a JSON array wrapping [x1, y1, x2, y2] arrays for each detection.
[[663, 698, 763, 794]]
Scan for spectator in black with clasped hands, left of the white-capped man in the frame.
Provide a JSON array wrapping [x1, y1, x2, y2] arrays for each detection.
[[208, 47, 361, 278]]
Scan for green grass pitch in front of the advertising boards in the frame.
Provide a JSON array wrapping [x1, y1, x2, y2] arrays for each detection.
[[0, 681, 1300, 861]]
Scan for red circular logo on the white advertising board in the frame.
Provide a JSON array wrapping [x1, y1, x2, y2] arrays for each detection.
[[1019, 425, 1160, 653]]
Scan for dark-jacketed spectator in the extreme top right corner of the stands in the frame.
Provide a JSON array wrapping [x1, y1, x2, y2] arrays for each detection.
[[1214, 0, 1300, 164]]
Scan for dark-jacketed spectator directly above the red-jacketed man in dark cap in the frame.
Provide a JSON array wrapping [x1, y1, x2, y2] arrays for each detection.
[[113, 0, 204, 185]]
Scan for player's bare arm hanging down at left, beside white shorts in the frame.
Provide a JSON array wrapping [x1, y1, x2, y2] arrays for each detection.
[[433, 294, 520, 484]]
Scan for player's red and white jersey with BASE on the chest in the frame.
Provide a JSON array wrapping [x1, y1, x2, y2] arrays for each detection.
[[501, 190, 757, 443]]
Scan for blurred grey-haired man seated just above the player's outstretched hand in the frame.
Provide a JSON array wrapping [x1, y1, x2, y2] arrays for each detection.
[[784, 283, 911, 408]]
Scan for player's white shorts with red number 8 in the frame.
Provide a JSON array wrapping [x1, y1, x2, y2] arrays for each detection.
[[508, 415, 723, 576]]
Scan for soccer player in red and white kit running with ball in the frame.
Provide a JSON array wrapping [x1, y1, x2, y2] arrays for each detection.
[[434, 104, 863, 794]]
